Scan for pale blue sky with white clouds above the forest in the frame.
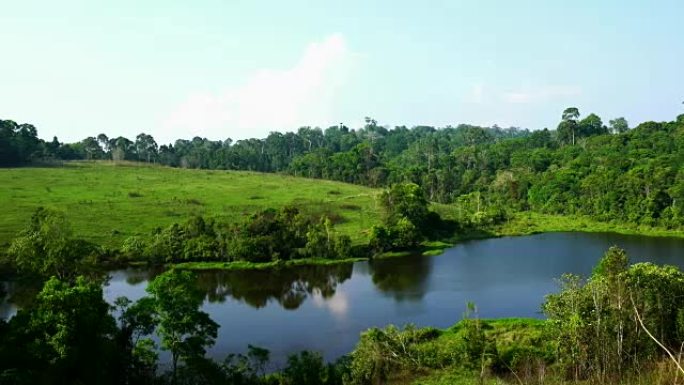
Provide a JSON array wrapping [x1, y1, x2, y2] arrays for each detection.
[[0, 0, 684, 144]]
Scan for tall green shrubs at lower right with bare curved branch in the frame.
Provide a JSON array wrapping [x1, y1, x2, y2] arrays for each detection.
[[544, 247, 684, 381]]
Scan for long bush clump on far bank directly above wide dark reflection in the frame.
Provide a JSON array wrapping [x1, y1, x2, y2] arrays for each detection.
[[121, 207, 353, 263]]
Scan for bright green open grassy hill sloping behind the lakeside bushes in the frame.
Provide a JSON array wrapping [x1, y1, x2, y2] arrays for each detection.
[[0, 162, 379, 248]]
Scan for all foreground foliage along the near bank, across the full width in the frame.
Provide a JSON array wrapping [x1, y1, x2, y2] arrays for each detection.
[[0, 246, 684, 385]]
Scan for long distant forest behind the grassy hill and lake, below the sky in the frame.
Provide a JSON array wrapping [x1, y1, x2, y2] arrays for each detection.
[[0, 107, 684, 228]]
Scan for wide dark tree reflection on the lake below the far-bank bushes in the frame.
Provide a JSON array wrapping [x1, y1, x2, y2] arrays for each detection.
[[192, 263, 353, 310]]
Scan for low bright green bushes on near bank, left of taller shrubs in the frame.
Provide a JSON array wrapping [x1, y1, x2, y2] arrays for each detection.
[[347, 313, 553, 384]]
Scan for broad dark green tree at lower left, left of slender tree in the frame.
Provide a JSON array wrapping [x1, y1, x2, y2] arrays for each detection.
[[12, 277, 119, 384]]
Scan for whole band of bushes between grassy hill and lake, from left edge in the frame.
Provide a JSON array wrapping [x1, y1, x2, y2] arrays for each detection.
[[5, 207, 356, 279]]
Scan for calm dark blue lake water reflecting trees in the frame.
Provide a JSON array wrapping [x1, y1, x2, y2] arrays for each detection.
[[0, 233, 684, 365]]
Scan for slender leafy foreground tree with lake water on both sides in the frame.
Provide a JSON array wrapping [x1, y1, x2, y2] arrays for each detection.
[[146, 270, 218, 383]]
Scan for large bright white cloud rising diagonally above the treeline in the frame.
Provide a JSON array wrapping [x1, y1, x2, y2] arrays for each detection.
[[163, 34, 355, 139]]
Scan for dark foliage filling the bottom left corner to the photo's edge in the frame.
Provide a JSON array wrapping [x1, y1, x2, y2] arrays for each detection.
[[0, 277, 123, 384]]
